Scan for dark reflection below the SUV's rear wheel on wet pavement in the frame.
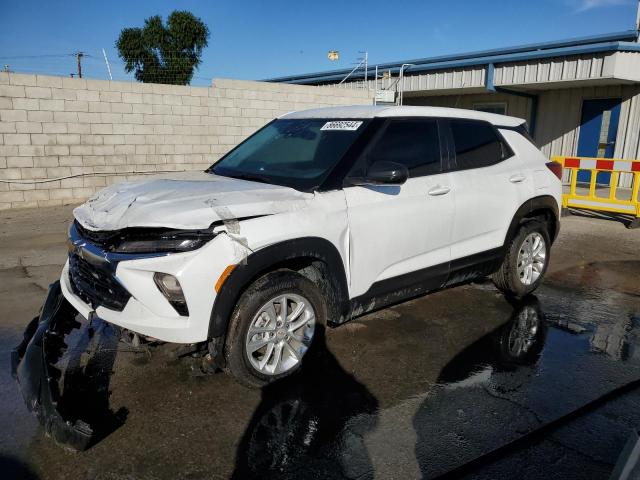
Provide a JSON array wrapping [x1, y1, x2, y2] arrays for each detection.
[[414, 296, 547, 478]]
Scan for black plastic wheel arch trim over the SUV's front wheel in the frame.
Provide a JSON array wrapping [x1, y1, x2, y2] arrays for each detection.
[[208, 237, 349, 339]]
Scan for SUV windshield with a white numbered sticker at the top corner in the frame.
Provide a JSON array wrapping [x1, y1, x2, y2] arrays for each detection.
[[207, 118, 367, 191]]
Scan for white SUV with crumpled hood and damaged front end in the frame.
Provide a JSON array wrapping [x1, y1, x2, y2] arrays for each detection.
[[60, 106, 561, 385]]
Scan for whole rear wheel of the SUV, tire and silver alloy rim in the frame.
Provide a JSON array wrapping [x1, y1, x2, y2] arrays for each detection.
[[491, 220, 551, 297]]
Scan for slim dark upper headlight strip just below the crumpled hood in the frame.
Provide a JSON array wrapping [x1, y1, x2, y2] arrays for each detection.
[[113, 230, 215, 253]]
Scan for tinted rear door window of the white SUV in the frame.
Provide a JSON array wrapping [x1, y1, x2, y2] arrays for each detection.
[[449, 120, 508, 169]]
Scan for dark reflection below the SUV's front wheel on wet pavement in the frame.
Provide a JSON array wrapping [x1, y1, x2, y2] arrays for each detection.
[[233, 331, 378, 479]]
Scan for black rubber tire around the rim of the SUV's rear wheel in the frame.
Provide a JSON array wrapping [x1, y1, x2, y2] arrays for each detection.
[[491, 220, 551, 298]]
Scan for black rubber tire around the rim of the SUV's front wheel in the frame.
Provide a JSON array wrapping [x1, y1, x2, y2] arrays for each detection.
[[225, 270, 327, 388]]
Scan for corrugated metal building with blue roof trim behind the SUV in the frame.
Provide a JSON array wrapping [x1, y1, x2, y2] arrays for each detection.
[[268, 30, 640, 186]]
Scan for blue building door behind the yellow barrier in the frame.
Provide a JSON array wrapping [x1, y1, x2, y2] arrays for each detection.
[[578, 98, 620, 185]]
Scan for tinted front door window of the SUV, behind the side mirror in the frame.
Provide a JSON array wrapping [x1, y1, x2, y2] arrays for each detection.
[[368, 119, 440, 177]]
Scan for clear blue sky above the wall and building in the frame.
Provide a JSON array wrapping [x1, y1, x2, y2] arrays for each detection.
[[0, 0, 638, 85]]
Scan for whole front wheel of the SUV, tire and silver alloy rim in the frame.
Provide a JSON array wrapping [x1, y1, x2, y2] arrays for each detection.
[[225, 270, 326, 387]]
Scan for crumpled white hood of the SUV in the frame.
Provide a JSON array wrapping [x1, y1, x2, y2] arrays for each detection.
[[73, 172, 313, 230]]
